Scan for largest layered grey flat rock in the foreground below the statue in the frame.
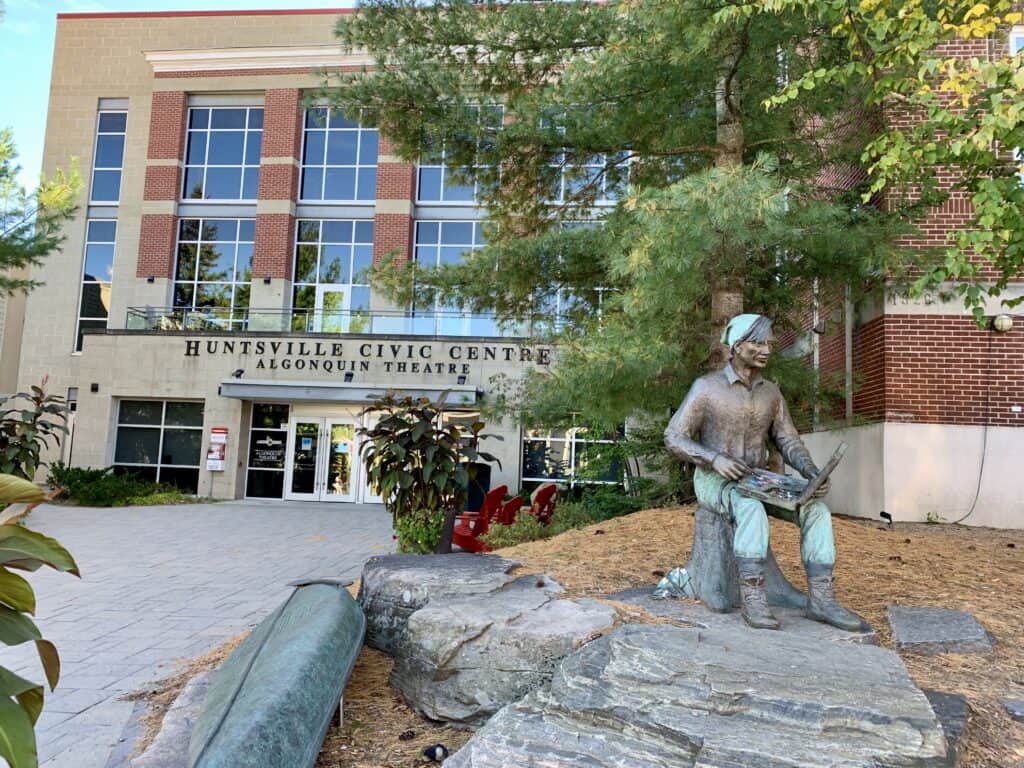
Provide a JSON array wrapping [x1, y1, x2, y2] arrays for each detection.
[[445, 625, 948, 768]]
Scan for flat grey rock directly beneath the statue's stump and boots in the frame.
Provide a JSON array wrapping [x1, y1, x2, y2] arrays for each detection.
[[607, 587, 879, 645]]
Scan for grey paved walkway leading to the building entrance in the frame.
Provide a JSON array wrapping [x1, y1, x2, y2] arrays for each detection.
[[0, 501, 393, 768]]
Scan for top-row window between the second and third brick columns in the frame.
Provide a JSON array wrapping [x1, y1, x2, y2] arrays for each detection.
[[300, 106, 377, 203]]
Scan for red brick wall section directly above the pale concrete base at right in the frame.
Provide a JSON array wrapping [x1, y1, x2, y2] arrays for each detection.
[[880, 314, 1024, 426]]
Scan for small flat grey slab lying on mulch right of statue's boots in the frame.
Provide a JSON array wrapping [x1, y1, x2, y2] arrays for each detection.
[[886, 605, 995, 655]]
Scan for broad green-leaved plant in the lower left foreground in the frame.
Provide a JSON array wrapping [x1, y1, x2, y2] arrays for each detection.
[[0, 474, 79, 768]]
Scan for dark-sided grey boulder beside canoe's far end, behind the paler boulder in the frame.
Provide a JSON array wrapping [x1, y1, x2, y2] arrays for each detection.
[[357, 552, 519, 655]]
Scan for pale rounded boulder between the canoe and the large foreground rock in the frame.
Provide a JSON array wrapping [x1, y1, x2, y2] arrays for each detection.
[[391, 575, 615, 727]]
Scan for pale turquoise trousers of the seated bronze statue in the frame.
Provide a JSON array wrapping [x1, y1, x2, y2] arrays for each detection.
[[693, 467, 836, 566]]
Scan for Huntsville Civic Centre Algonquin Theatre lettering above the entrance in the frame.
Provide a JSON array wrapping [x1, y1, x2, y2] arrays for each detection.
[[184, 339, 552, 379]]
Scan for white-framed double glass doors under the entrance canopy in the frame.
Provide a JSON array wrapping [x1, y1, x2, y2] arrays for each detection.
[[285, 417, 356, 502]]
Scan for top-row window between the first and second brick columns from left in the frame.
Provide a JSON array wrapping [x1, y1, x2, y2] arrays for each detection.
[[181, 106, 263, 201]]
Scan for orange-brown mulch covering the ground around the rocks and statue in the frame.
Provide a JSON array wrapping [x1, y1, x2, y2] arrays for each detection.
[[138, 507, 1024, 768]]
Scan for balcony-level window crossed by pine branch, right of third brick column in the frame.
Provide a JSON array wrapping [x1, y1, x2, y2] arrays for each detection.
[[414, 221, 498, 336]]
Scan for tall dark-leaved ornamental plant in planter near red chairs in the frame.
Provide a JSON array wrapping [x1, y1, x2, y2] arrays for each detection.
[[357, 392, 500, 554]]
